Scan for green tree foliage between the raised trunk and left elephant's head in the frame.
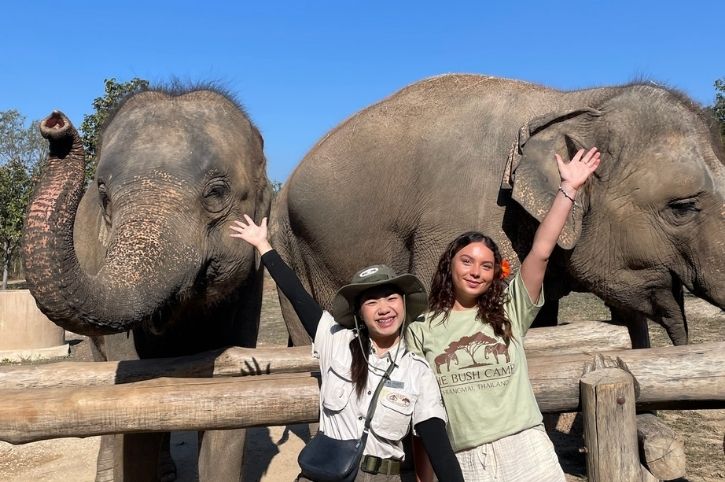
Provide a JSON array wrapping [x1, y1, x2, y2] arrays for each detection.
[[81, 77, 149, 182]]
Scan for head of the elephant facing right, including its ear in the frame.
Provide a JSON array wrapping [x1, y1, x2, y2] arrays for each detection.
[[504, 85, 725, 344]]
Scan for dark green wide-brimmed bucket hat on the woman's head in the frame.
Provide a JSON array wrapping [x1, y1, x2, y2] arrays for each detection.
[[332, 264, 428, 328]]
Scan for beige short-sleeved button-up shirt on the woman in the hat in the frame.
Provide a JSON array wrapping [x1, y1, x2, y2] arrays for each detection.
[[312, 311, 447, 460]]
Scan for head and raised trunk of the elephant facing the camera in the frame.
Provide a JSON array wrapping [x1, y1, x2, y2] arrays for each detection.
[[23, 89, 270, 334]]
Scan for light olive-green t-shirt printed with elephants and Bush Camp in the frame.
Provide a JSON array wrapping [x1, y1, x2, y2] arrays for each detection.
[[405, 273, 544, 452]]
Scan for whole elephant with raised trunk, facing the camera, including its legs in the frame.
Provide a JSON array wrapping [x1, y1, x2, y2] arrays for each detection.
[[23, 90, 270, 482]]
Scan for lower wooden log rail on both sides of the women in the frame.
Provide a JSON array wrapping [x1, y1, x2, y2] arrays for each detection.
[[0, 342, 725, 443]]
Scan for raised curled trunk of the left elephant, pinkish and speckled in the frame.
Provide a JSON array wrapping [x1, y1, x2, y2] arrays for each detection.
[[22, 111, 188, 335]]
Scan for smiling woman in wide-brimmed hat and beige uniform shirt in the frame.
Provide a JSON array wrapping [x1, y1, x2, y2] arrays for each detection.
[[231, 215, 463, 482]]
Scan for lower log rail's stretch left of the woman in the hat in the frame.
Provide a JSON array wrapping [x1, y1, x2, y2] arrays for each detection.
[[0, 373, 320, 444]]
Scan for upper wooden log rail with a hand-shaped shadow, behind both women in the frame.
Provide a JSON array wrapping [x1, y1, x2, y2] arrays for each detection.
[[0, 321, 631, 390]]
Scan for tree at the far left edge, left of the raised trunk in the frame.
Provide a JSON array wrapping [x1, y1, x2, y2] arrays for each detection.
[[0, 110, 48, 289]]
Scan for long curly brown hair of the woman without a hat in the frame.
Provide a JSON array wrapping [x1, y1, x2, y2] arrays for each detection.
[[428, 231, 514, 345]]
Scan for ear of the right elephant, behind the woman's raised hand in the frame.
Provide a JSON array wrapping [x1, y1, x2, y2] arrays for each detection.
[[501, 108, 601, 249]]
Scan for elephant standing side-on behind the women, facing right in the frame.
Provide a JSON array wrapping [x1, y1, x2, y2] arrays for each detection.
[[272, 75, 725, 347]]
